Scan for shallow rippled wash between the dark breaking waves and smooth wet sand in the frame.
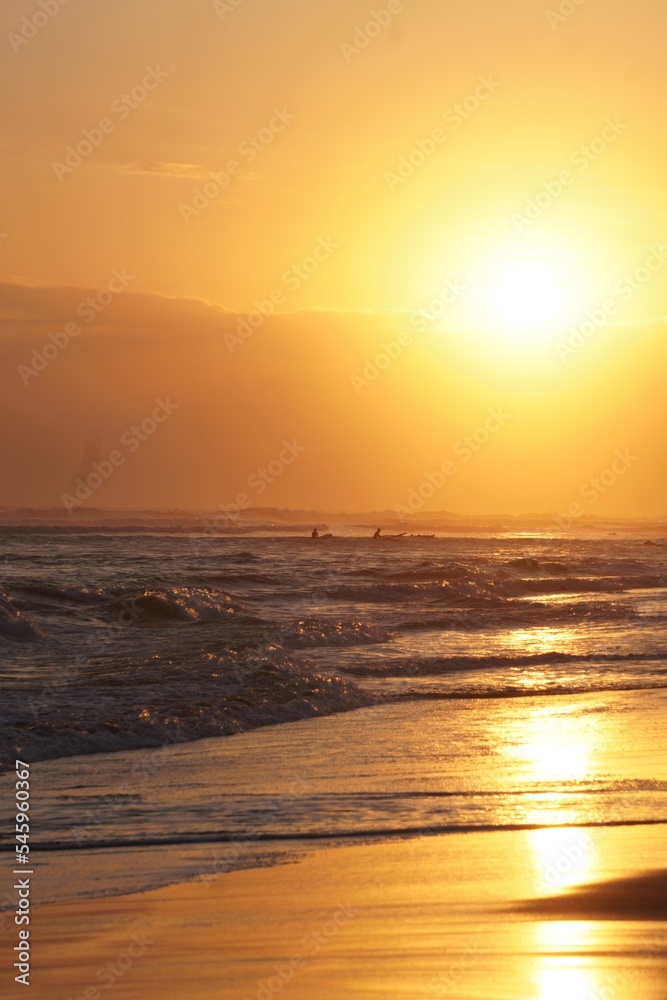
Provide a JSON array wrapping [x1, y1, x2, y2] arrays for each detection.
[[5, 692, 667, 916]]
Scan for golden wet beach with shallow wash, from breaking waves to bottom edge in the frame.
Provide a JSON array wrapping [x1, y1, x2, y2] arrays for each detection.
[[2, 693, 667, 1000]]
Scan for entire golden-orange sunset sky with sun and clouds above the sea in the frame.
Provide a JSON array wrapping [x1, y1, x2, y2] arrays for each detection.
[[0, 0, 667, 516]]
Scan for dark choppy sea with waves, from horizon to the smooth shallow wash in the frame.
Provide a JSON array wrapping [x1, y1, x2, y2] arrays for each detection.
[[0, 530, 667, 761]]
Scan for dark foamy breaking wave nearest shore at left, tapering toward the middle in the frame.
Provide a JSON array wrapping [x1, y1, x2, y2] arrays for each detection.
[[0, 655, 373, 768]]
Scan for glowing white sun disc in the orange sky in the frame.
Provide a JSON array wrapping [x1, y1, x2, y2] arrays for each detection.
[[467, 241, 593, 344]]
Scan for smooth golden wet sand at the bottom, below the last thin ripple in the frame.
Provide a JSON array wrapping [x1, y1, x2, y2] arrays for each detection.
[[9, 825, 667, 1000]]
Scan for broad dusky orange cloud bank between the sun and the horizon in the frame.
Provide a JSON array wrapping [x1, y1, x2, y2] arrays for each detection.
[[0, 279, 667, 512]]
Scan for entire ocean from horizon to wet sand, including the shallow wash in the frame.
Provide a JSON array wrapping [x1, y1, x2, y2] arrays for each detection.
[[0, 530, 667, 899]]
